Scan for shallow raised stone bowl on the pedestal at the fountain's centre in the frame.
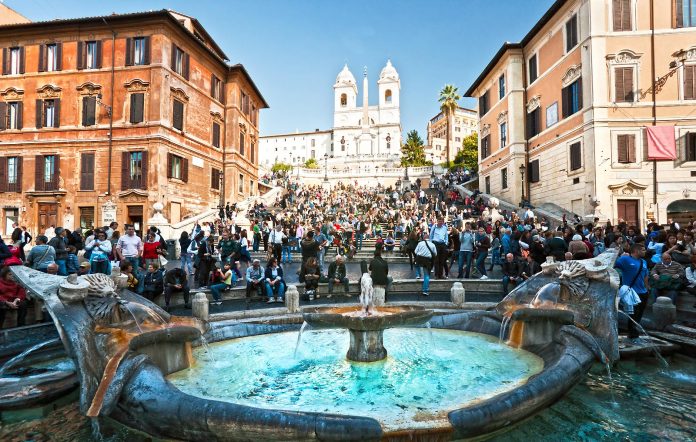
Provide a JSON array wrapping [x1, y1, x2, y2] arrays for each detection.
[[302, 306, 433, 331]]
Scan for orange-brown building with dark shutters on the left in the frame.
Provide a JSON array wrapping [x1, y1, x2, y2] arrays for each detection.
[[0, 10, 267, 235]]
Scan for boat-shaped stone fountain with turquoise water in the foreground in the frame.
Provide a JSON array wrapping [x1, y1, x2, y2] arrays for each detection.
[[5, 250, 619, 440]]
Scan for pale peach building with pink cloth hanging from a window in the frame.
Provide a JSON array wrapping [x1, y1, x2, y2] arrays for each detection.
[[465, 0, 696, 227]]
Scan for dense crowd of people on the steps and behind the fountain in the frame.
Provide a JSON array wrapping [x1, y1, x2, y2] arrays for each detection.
[[0, 171, 696, 332]]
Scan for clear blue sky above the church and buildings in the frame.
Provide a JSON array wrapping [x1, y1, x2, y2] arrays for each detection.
[[4, 0, 553, 138]]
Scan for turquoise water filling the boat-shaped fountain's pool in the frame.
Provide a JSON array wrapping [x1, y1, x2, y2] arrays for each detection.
[[167, 329, 543, 431]]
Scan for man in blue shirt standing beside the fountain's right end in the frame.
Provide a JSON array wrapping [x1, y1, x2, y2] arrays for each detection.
[[614, 243, 649, 339]]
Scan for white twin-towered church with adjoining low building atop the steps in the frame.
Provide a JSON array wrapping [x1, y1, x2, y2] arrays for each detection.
[[259, 60, 401, 174]]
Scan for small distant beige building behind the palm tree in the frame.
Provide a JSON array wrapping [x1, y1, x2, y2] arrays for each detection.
[[425, 107, 478, 164]]
